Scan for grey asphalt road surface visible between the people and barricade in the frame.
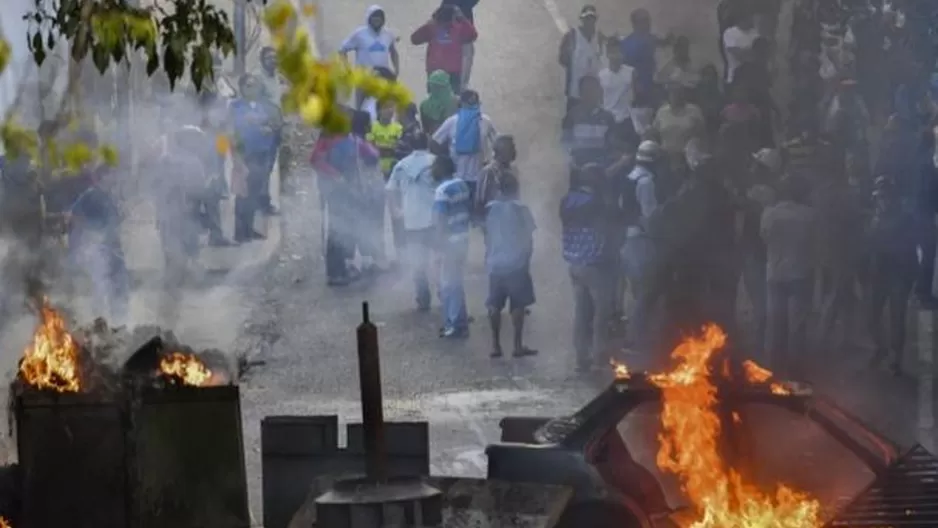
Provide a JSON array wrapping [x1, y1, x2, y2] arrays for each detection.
[[232, 0, 928, 520]]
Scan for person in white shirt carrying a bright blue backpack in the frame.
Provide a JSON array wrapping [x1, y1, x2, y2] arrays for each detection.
[[433, 90, 498, 207]]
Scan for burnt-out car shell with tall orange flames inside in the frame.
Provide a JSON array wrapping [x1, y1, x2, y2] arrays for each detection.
[[487, 326, 938, 528]]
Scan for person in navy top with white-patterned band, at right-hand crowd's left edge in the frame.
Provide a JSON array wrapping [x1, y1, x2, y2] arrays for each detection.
[[560, 163, 617, 372]]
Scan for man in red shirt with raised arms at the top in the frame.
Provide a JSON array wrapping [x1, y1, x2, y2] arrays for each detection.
[[410, 4, 479, 93]]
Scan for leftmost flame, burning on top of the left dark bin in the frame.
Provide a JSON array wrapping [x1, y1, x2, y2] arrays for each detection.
[[19, 299, 81, 392]]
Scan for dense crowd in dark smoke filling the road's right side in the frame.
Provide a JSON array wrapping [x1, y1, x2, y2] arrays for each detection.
[[559, 0, 938, 375]]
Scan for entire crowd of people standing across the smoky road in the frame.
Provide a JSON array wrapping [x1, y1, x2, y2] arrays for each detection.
[[22, 0, 938, 375]]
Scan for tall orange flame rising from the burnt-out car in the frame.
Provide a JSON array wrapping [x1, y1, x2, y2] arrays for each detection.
[[649, 325, 820, 528]]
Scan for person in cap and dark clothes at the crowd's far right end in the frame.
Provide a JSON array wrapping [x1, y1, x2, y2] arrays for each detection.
[[868, 176, 918, 374]]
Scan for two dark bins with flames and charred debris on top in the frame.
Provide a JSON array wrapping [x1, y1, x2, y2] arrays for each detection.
[[11, 301, 249, 528]]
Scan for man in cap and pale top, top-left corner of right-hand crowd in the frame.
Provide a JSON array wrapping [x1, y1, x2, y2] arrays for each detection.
[[559, 5, 606, 128]]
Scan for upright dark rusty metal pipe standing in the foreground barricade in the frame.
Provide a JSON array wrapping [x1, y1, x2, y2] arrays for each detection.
[[356, 302, 388, 481]]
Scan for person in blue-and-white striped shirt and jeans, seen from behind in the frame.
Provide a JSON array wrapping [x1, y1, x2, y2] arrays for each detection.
[[433, 156, 472, 339]]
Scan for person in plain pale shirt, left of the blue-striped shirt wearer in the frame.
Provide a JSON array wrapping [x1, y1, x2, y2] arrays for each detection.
[[385, 133, 437, 312]]
